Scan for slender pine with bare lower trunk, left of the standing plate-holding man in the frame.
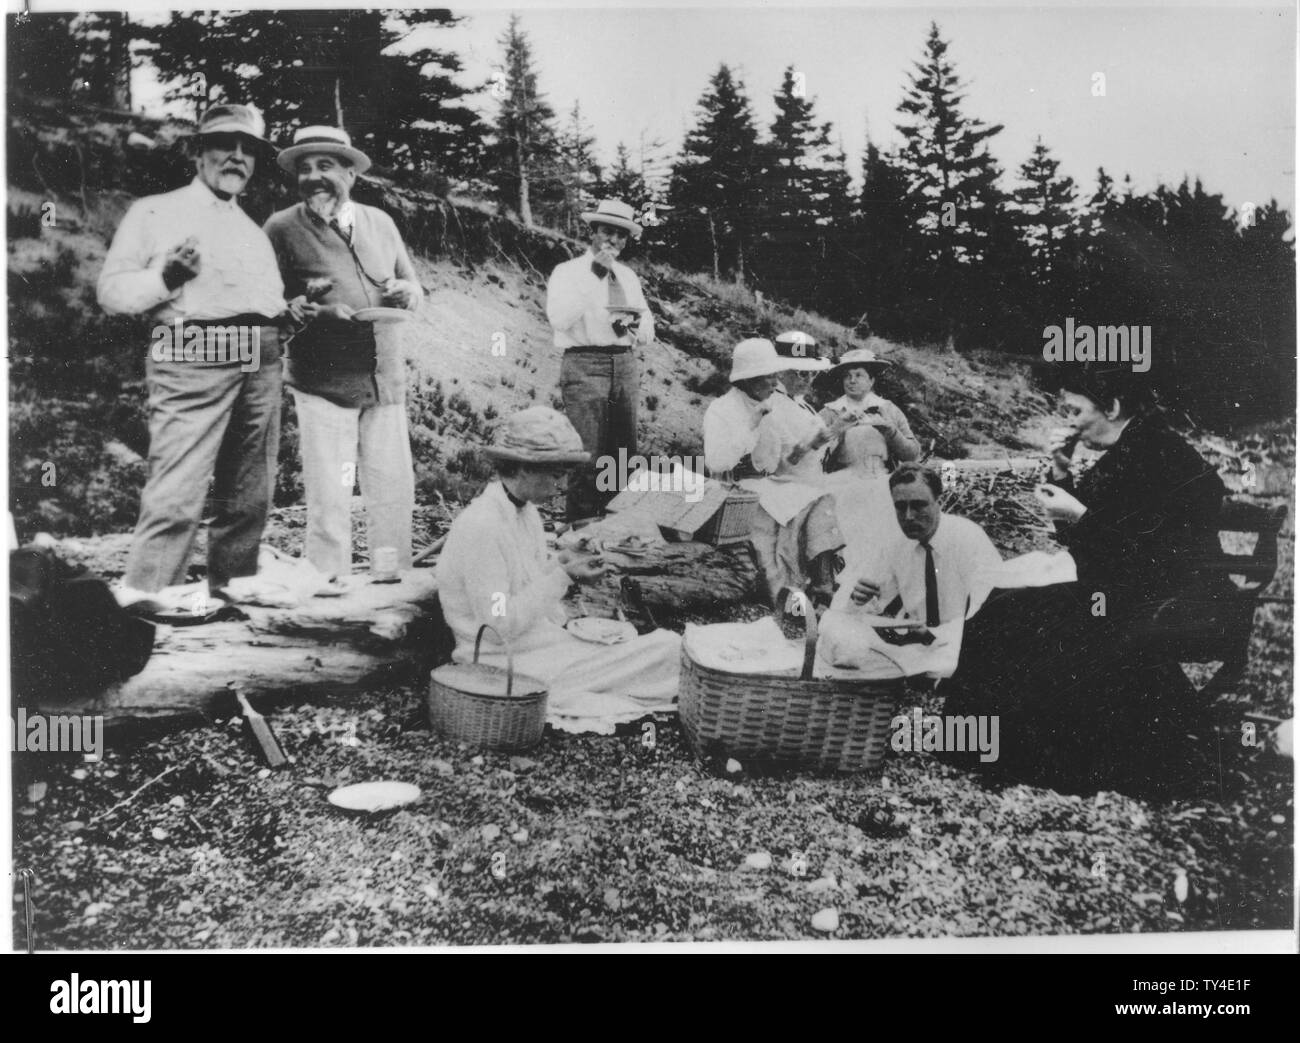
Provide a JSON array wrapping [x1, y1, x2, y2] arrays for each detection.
[[493, 14, 559, 225]]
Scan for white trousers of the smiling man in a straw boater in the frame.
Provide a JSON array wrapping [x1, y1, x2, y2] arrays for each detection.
[[293, 388, 415, 576]]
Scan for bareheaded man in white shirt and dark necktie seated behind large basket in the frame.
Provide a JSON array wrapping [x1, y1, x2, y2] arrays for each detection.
[[822, 463, 1002, 661]]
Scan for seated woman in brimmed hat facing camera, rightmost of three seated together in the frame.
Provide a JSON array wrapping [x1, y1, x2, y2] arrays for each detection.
[[822, 347, 920, 571]]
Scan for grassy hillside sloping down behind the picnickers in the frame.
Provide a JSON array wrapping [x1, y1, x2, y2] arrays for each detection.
[[7, 91, 1048, 535]]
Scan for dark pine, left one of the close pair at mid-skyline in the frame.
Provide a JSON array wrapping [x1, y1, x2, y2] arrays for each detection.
[[668, 65, 767, 282]]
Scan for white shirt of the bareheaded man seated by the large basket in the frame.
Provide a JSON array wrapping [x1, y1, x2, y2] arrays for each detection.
[[831, 514, 1002, 623]]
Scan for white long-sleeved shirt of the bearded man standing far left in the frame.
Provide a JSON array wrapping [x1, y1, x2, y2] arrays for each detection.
[[99, 178, 285, 323]]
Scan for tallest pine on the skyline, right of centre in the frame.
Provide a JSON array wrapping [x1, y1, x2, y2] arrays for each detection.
[[897, 22, 1002, 272]]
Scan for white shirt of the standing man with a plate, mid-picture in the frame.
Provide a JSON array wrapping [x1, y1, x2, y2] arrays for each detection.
[[546, 250, 654, 349]]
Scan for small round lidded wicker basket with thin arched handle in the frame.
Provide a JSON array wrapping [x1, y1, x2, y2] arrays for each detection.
[[428, 623, 547, 753]]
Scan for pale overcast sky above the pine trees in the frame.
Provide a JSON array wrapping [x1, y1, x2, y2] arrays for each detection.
[[55, 0, 1296, 213]]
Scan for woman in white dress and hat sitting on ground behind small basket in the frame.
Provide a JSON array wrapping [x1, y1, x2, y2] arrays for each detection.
[[438, 407, 681, 732]]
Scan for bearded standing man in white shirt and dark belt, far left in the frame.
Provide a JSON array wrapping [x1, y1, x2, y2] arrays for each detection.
[[98, 104, 285, 608]]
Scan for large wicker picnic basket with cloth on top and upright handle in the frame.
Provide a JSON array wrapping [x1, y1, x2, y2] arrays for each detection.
[[677, 609, 902, 771]]
